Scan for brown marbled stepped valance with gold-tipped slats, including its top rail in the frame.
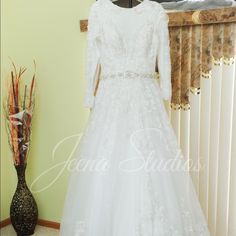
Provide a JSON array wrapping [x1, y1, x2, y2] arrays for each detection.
[[159, 8, 236, 110]]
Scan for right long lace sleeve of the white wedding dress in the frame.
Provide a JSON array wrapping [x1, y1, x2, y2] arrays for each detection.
[[156, 9, 172, 101]]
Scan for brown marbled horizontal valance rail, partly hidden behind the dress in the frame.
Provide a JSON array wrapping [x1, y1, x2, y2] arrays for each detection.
[[80, 6, 236, 32]]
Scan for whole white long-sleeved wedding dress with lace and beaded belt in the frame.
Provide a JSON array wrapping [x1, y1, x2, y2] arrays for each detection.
[[60, 0, 210, 236]]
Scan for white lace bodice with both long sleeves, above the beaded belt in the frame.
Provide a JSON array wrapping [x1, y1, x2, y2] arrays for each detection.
[[84, 0, 171, 108]]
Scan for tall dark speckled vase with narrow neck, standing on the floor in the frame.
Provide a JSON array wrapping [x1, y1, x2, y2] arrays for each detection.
[[10, 163, 38, 236]]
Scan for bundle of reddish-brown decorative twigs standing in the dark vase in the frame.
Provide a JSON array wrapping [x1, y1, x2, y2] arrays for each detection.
[[5, 61, 36, 165]]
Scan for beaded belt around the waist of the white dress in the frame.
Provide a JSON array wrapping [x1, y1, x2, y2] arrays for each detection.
[[100, 71, 157, 79]]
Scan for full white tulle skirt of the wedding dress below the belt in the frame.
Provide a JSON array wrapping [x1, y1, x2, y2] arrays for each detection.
[[60, 79, 209, 236]]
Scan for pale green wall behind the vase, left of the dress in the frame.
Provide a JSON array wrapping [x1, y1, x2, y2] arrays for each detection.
[[0, 0, 94, 222]]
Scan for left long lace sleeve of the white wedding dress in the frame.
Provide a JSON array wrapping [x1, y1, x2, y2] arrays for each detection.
[[84, 4, 100, 108]]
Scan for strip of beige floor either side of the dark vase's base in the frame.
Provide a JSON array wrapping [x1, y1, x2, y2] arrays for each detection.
[[0, 225, 59, 236]]
